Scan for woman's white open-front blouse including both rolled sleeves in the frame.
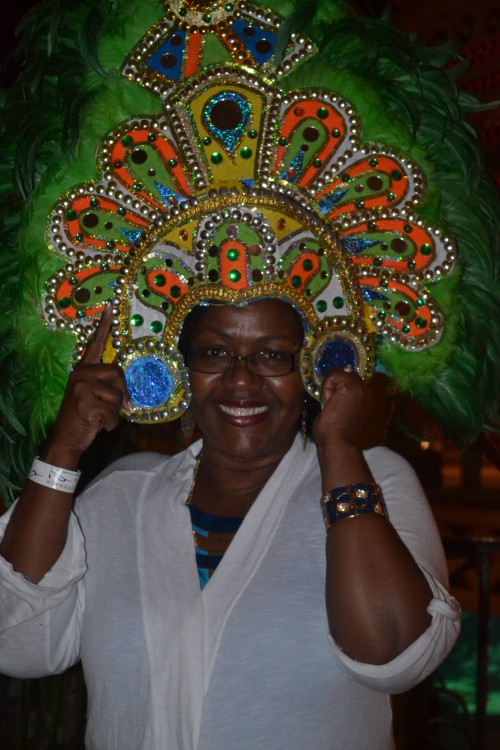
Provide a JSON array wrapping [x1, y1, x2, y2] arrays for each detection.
[[0, 438, 460, 750]]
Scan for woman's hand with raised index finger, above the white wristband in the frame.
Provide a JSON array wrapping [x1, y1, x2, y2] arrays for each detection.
[[44, 309, 130, 468]]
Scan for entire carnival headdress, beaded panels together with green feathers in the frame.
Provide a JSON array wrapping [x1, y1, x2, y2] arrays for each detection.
[[1, 0, 500, 500]]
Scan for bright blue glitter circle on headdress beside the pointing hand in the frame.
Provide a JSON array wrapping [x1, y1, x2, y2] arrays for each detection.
[[125, 357, 175, 409]]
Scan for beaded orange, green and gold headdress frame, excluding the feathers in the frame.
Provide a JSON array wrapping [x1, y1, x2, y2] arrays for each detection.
[[42, 0, 455, 422]]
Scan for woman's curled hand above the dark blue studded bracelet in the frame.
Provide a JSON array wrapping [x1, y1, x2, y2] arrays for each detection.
[[313, 368, 369, 448]]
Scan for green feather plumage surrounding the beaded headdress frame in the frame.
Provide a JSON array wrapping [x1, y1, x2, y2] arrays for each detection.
[[0, 0, 500, 501]]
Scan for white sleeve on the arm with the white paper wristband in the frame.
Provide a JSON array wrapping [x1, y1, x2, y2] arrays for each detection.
[[0, 500, 86, 677]]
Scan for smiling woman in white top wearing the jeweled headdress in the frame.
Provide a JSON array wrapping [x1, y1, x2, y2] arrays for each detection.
[[0, 0, 484, 750]]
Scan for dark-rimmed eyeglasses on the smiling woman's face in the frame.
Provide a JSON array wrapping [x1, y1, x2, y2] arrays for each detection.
[[188, 347, 300, 378]]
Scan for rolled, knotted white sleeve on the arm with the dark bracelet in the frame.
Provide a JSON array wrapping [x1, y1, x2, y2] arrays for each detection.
[[332, 448, 461, 693]]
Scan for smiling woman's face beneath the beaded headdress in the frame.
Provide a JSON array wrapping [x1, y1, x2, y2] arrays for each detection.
[[189, 300, 304, 461]]
